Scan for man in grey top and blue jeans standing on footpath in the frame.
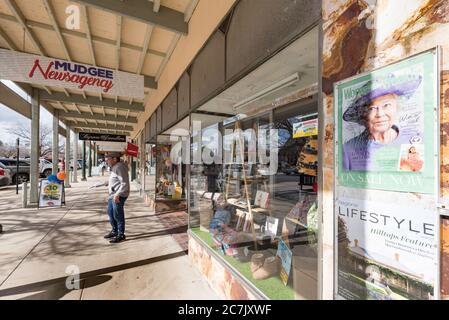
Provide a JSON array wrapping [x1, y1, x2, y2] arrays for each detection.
[[104, 152, 130, 243]]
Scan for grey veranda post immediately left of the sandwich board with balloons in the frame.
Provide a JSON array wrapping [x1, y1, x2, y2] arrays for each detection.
[[30, 88, 40, 204]]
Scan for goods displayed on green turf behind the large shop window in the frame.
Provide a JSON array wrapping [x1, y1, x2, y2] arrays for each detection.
[[189, 102, 318, 299]]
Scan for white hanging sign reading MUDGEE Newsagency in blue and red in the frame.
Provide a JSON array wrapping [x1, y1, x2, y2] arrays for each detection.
[[0, 49, 144, 99]]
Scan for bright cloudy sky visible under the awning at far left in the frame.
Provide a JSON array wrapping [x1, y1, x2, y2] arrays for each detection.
[[0, 81, 53, 144]]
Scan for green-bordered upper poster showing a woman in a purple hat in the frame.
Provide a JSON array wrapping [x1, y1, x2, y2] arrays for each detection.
[[335, 52, 438, 194]]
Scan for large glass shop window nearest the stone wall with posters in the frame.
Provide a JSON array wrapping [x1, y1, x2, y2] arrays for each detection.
[[189, 27, 320, 300]]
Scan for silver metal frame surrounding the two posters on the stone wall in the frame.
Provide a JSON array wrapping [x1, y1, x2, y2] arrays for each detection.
[[333, 46, 444, 300]]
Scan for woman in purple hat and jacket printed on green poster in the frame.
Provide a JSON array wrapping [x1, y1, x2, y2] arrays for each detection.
[[343, 74, 422, 171]]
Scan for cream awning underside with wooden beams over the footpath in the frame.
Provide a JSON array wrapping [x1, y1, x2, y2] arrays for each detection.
[[0, 0, 198, 134]]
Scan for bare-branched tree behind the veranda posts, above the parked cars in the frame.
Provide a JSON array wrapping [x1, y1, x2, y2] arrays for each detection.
[[8, 124, 64, 158]]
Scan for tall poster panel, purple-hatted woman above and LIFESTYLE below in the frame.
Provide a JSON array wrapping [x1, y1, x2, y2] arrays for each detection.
[[334, 50, 438, 300]]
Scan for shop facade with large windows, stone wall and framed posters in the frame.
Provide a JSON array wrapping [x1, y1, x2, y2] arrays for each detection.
[[137, 0, 449, 300]]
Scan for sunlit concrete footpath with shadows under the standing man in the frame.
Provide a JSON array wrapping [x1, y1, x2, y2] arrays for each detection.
[[0, 177, 218, 300]]
